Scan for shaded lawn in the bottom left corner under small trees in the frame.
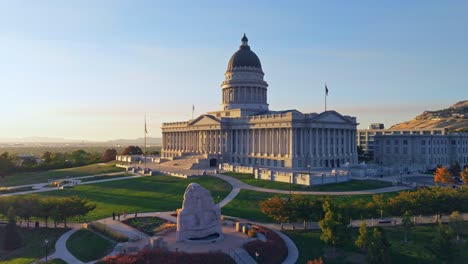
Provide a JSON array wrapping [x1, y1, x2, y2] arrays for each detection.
[[0, 226, 69, 264]]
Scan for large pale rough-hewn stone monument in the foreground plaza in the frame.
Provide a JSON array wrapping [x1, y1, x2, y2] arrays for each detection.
[[176, 183, 223, 243]]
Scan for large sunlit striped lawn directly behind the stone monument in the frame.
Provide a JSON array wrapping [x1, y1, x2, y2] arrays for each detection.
[[38, 175, 232, 221]]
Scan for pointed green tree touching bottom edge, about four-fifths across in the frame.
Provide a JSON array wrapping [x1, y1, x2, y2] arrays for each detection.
[[366, 227, 390, 264]]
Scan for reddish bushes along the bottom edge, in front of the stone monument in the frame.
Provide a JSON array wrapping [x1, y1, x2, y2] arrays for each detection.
[[98, 249, 236, 264]]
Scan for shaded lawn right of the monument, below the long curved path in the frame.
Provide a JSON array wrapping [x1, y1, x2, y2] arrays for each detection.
[[221, 190, 397, 223]]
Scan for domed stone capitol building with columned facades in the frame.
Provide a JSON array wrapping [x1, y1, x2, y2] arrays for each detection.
[[161, 35, 357, 170]]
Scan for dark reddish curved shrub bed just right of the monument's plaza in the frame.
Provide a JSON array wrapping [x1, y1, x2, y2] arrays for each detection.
[[244, 227, 288, 264]]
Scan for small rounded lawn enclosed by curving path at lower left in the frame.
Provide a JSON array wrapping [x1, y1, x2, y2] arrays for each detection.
[[67, 229, 115, 262]]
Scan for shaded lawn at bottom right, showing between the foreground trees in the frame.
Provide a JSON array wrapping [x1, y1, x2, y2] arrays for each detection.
[[284, 222, 468, 264]]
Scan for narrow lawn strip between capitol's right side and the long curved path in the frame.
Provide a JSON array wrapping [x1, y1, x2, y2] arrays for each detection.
[[224, 172, 392, 192]]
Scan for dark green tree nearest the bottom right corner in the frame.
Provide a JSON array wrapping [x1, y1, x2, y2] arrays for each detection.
[[428, 223, 460, 263]]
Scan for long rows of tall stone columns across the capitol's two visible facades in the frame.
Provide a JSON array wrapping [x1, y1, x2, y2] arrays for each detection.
[[163, 128, 356, 157]]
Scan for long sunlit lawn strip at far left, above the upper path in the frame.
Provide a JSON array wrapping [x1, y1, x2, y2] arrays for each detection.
[[0, 161, 124, 186]]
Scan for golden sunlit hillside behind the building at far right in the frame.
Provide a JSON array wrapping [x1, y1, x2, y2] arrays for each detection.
[[390, 100, 468, 132]]
